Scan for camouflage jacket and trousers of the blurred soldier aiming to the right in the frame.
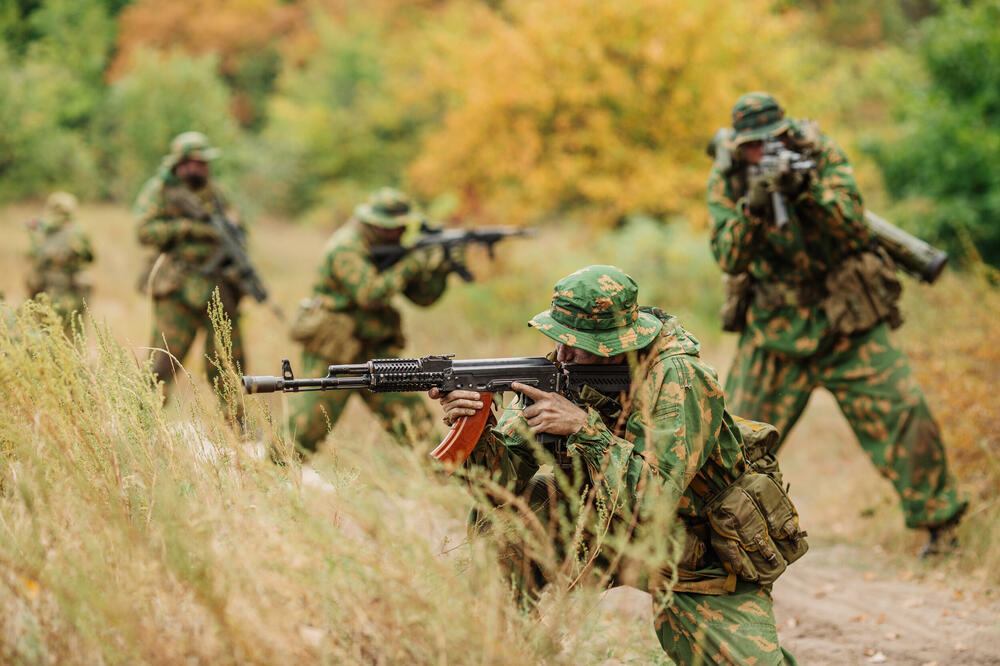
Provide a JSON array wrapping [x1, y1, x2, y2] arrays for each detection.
[[289, 219, 448, 451]]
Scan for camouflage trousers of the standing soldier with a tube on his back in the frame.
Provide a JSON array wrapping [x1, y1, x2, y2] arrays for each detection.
[[726, 324, 967, 528]]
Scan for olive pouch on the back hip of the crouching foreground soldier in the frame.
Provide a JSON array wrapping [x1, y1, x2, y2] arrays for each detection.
[[689, 419, 809, 584]]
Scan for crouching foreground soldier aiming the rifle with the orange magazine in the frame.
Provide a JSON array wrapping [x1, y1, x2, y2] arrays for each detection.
[[430, 266, 796, 664]]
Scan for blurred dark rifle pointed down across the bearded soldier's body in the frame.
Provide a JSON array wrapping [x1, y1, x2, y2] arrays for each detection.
[[175, 195, 285, 320]]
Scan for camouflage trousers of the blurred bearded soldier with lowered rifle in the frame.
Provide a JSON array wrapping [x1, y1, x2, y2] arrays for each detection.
[[149, 285, 246, 394]]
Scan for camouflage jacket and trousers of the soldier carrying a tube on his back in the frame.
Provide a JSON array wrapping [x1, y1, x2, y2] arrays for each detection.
[[708, 102, 966, 527]]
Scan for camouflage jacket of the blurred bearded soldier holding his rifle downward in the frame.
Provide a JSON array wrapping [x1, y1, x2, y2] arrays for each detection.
[[135, 171, 245, 307]]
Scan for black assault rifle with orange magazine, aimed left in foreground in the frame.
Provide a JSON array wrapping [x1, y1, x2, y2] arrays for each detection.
[[243, 354, 630, 465]]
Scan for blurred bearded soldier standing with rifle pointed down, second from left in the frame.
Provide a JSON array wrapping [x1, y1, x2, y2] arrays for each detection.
[[135, 132, 246, 396]]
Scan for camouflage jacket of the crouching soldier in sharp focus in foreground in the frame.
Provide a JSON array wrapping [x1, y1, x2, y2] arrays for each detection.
[[475, 315, 745, 518]]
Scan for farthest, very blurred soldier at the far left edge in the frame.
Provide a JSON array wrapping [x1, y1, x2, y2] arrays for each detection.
[[26, 192, 94, 332]]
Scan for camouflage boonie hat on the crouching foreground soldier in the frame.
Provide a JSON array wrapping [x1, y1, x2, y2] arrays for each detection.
[[528, 266, 663, 357]]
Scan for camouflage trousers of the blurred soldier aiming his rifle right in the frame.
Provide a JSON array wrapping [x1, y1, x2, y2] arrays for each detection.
[[288, 347, 434, 451]]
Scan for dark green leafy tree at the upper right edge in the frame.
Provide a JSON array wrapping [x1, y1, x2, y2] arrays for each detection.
[[871, 0, 1000, 266]]
